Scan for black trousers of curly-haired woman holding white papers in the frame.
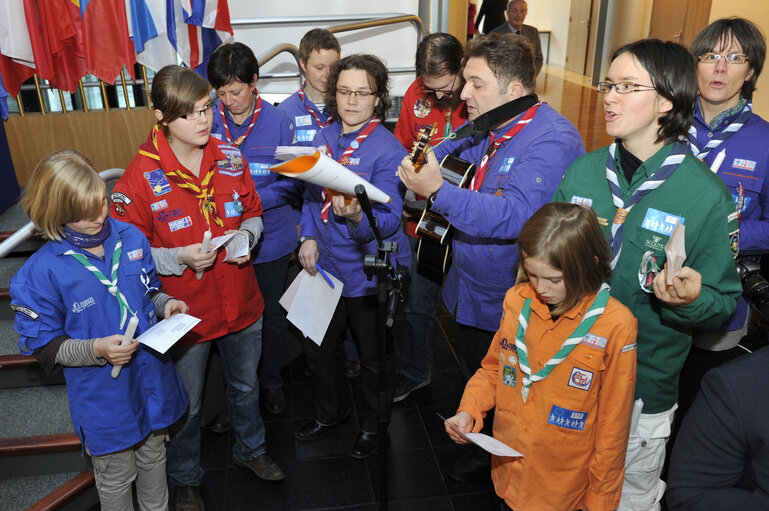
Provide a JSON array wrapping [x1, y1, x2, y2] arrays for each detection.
[[303, 295, 395, 433]]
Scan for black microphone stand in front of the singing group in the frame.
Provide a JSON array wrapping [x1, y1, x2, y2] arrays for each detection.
[[355, 185, 408, 511]]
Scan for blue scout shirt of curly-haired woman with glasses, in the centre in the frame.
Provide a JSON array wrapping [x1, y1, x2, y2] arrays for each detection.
[[301, 122, 411, 297]]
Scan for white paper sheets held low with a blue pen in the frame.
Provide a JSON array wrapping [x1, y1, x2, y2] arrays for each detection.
[[279, 270, 344, 346]]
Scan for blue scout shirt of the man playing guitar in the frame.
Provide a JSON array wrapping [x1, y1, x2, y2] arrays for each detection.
[[432, 104, 585, 331]]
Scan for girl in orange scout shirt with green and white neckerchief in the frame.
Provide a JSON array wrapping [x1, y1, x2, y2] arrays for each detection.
[[446, 202, 637, 511]]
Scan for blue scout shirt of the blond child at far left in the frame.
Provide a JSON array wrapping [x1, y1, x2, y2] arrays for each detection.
[[11, 219, 187, 456]]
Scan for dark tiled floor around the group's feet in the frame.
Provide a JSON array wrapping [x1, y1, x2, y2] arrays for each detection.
[[179, 310, 498, 511]]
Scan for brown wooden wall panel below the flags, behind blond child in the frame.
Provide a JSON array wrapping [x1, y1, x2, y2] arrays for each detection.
[[5, 108, 155, 186]]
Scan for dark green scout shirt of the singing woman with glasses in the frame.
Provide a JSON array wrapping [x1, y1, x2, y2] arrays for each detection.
[[553, 144, 742, 413]]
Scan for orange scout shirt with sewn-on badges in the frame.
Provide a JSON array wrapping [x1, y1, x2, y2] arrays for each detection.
[[459, 283, 637, 511]]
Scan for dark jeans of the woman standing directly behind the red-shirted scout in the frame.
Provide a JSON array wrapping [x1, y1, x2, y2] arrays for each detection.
[[254, 254, 291, 389]]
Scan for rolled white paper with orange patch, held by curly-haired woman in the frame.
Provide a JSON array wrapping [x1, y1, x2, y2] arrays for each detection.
[[270, 146, 396, 204]]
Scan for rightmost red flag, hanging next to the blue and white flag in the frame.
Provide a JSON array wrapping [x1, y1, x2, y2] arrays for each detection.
[[81, 0, 136, 83]]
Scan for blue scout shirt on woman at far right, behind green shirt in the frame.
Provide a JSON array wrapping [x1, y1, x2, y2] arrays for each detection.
[[694, 101, 769, 330]]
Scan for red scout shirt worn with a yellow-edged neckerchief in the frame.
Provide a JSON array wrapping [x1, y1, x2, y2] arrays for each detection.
[[112, 127, 264, 345]]
